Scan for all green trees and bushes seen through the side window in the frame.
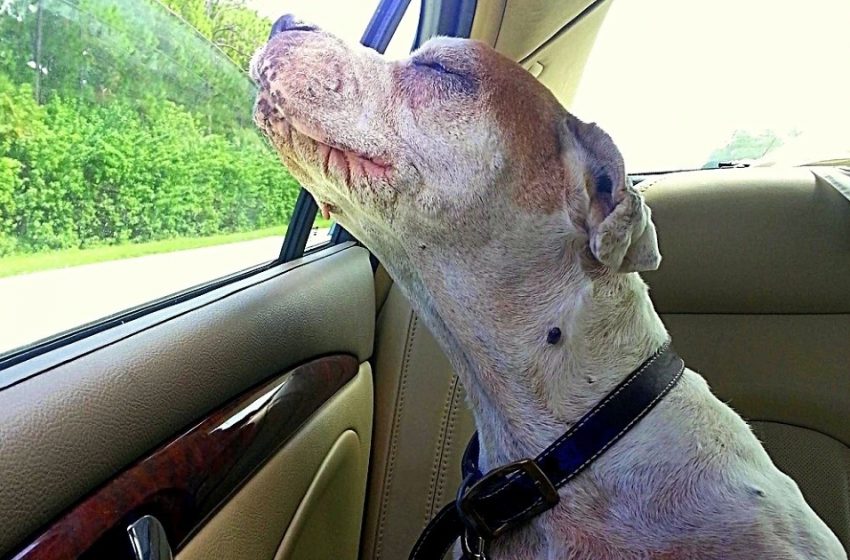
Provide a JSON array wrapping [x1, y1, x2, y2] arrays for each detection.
[[0, 0, 298, 255]]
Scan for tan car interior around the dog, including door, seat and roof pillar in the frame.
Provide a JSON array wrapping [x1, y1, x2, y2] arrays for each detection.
[[0, 0, 850, 560]]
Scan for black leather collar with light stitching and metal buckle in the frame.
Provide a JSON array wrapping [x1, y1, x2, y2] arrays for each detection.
[[410, 342, 685, 560]]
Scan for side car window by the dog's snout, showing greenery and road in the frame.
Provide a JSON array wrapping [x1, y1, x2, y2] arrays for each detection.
[[0, 0, 415, 353]]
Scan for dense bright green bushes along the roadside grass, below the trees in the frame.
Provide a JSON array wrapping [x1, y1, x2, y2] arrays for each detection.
[[0, 75, 298, 253]]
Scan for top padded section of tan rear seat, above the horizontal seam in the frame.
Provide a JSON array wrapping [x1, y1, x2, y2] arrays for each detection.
[[638, 168, 850, 313]]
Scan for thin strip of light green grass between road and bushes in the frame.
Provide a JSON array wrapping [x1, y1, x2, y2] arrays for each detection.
[[0, 216, 331, 278]]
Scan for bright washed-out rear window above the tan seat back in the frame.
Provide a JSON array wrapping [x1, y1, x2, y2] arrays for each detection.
[[572, 0, 850, 173]]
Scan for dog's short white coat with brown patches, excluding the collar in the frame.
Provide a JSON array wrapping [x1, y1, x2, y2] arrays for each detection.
[[252, 24, 847, 560]]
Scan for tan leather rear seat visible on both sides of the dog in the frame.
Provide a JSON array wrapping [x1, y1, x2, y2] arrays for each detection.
[[361, 169, 850, 559]]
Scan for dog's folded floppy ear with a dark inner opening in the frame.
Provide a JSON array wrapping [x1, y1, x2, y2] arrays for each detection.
[[561, 115, 661, 272]]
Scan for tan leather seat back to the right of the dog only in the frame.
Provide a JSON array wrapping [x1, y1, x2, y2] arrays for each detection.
[[643, 168, 850, 548]]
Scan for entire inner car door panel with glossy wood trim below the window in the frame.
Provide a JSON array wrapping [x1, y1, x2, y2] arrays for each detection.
[[0, 244, 375, 560]]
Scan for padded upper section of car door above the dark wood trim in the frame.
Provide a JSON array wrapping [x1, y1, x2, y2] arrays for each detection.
[[0, 244, 375, 557]]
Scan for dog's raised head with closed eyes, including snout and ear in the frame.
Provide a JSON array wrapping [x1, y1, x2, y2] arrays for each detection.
[[251, 16, 660, 271]]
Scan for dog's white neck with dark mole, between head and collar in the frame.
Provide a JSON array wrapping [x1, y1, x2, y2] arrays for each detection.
[[356, 214, 667, 468]]
